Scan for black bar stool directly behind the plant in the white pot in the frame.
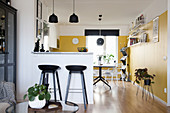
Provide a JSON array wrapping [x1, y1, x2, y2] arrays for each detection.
[[38, 65, 62, 102]]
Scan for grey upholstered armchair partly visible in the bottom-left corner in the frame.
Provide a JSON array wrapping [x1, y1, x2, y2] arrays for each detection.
[[0, 82, 16, 113]]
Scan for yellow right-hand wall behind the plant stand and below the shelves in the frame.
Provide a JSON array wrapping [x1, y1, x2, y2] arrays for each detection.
[[130, 12, 167, 102]]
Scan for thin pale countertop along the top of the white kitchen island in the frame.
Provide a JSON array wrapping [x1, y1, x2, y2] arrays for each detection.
[[31, 52, 93, 55]]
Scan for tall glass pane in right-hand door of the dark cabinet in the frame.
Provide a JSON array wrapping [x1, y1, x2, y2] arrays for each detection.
[[8, 13, 15, 63]]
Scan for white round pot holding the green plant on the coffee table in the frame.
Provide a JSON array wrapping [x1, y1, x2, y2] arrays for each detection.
[[28, 96, 46, 109]]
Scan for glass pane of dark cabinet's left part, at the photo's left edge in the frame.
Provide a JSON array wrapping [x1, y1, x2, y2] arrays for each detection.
[[0, 8, 6, 53]]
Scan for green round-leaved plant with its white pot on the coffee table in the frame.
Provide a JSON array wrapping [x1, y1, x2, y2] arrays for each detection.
[[24, 84, 51, 109]]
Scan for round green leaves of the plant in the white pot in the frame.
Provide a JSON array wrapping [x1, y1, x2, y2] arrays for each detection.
[[23, 84, 51, 101]]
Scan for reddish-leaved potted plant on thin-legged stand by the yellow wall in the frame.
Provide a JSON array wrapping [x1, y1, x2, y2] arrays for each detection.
[[134, 68, 155, 86]]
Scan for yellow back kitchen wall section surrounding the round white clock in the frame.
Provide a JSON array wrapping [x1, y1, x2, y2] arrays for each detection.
[[52, 36, 86, 52]]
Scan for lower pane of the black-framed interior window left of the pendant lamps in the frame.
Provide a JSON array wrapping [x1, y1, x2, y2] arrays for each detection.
[[36, 19, 42, 39]]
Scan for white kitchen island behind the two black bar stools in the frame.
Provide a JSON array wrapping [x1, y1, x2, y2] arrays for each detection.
[[31, 52, 93, 104]]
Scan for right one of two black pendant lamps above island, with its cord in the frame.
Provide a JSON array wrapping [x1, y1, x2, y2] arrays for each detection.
[[69, 0, 79, 23]]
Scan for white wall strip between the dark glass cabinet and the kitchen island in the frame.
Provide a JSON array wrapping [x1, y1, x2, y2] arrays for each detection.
[[12, 0, 35, 99]]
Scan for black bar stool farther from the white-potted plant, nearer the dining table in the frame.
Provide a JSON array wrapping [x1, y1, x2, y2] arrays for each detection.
[[65, 65, 88, 109]]
